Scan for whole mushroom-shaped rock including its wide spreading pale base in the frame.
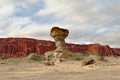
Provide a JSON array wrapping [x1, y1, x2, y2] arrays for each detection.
[[45, 27, 73, 61]]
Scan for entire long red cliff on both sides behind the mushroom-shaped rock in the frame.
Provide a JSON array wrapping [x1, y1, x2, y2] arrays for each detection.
[[0, 38, 120, 58]]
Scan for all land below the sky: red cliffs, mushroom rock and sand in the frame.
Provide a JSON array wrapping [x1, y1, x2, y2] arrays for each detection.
[[0, 27, 120, 80]]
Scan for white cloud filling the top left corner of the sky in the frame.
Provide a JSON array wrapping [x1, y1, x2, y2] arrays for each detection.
[[0, 0, 40, 19]]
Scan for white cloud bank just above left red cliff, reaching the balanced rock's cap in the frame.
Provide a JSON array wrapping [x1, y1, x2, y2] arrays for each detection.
[[0, 17, 51, 40]]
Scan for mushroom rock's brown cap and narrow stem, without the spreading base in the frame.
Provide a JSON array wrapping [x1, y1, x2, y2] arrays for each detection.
[[50, 27, 69, 57]]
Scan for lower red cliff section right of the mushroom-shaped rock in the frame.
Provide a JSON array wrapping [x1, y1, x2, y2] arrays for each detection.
[[67, 44, 117, 56]]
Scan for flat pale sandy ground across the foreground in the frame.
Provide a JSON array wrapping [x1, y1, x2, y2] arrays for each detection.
[[0, 57, 120, 80]]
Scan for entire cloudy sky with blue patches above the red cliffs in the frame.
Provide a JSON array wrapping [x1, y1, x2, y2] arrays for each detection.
[[0, 0, 120, 47]]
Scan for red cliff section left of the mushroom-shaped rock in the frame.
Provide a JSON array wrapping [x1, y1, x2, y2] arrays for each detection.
[[0, 38, 55, 58]]
